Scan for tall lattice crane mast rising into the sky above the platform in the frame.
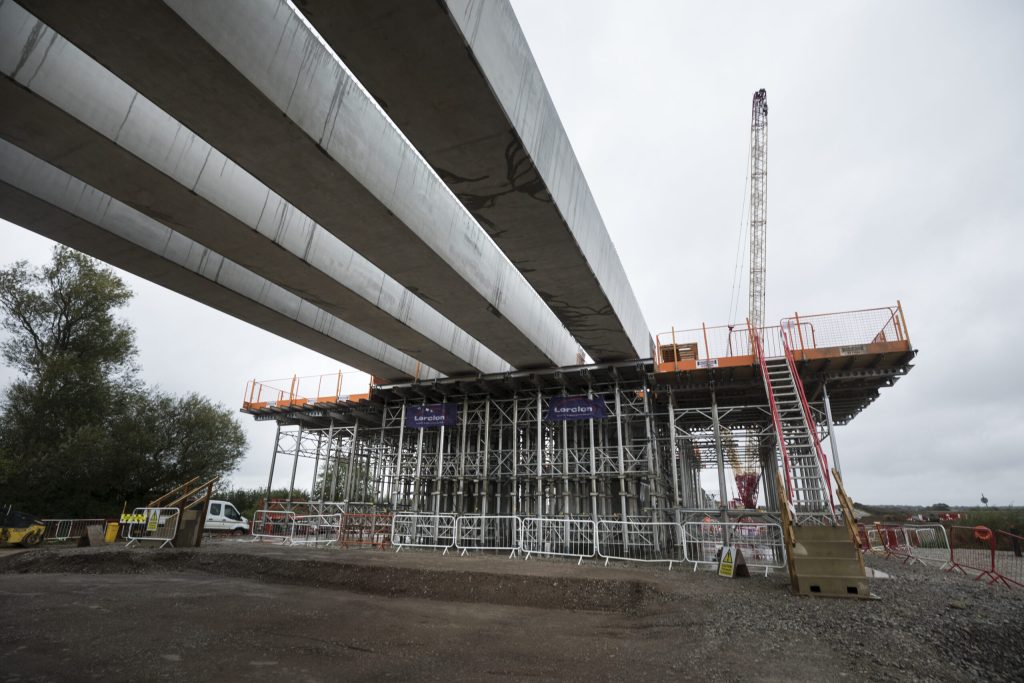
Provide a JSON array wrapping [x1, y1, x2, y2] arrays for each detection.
[[749, 88, 768, 331]]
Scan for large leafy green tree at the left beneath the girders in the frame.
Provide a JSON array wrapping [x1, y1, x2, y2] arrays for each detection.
[[0, 247, 246, 516]]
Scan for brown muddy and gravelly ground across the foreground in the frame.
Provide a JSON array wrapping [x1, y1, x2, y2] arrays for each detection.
[[0, 542, 1024, 681]]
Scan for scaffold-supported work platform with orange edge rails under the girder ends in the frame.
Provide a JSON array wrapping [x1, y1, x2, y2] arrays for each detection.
[[242, 304, 915, 521]]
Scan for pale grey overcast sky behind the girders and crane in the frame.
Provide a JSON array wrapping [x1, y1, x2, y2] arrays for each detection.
[[0, 0, 1024, 505]]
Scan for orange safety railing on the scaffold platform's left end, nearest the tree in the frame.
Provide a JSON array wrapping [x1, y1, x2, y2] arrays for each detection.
[[242, 371, 373, 410]]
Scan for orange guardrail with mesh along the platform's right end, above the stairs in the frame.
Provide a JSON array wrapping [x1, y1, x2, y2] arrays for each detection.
[[654, 302, 910, 372]]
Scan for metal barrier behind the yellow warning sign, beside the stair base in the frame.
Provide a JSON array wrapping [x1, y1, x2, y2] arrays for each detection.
[[683, 522, 785, 575]]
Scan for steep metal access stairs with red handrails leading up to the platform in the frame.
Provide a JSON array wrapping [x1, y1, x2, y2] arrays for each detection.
[[754, 327, 836, 523]]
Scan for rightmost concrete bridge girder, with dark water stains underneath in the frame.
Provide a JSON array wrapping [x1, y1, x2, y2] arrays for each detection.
[[297, 0, 651, 361]]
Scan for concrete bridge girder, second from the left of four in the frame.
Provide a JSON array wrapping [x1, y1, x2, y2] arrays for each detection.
[[0, 0, 510, 375]]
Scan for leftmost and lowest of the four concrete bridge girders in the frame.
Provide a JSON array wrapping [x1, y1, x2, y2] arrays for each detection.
[[0, 140, 440, 381]]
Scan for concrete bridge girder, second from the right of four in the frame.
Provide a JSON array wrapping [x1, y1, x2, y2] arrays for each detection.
[[25, 0, 578, 368]]
